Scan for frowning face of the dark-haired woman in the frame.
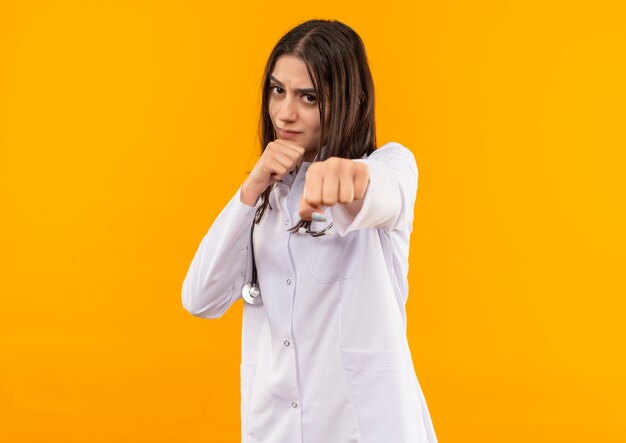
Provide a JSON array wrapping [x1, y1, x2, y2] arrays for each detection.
[[268, 55, 322, 161]]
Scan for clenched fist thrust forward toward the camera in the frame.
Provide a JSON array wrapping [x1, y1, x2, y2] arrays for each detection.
[[300, 157, 369, 220]]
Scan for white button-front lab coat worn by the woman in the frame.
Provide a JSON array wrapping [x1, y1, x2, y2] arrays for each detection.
[[182, 143, 437, 443]]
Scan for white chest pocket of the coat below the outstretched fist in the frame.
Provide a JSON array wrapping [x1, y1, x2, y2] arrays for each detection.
[[309, 222, 361, 283]]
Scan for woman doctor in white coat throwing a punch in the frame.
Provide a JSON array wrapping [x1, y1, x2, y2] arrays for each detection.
[[182, 20, 437, 443]]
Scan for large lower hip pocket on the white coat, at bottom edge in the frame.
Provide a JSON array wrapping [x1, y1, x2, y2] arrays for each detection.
[[342, 351, 426, 443]]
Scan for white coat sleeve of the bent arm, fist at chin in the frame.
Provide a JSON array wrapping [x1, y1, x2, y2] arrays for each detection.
[[182, 187, 260, 318]]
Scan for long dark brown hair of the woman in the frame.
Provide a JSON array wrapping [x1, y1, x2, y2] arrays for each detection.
[[255, 20, 376, 225]]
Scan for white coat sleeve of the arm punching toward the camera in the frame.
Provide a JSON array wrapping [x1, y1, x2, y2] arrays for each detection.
[[329, 142, 418, 236]]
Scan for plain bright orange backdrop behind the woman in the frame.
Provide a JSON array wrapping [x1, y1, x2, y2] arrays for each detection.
[[0, 0, 626, 443]]
